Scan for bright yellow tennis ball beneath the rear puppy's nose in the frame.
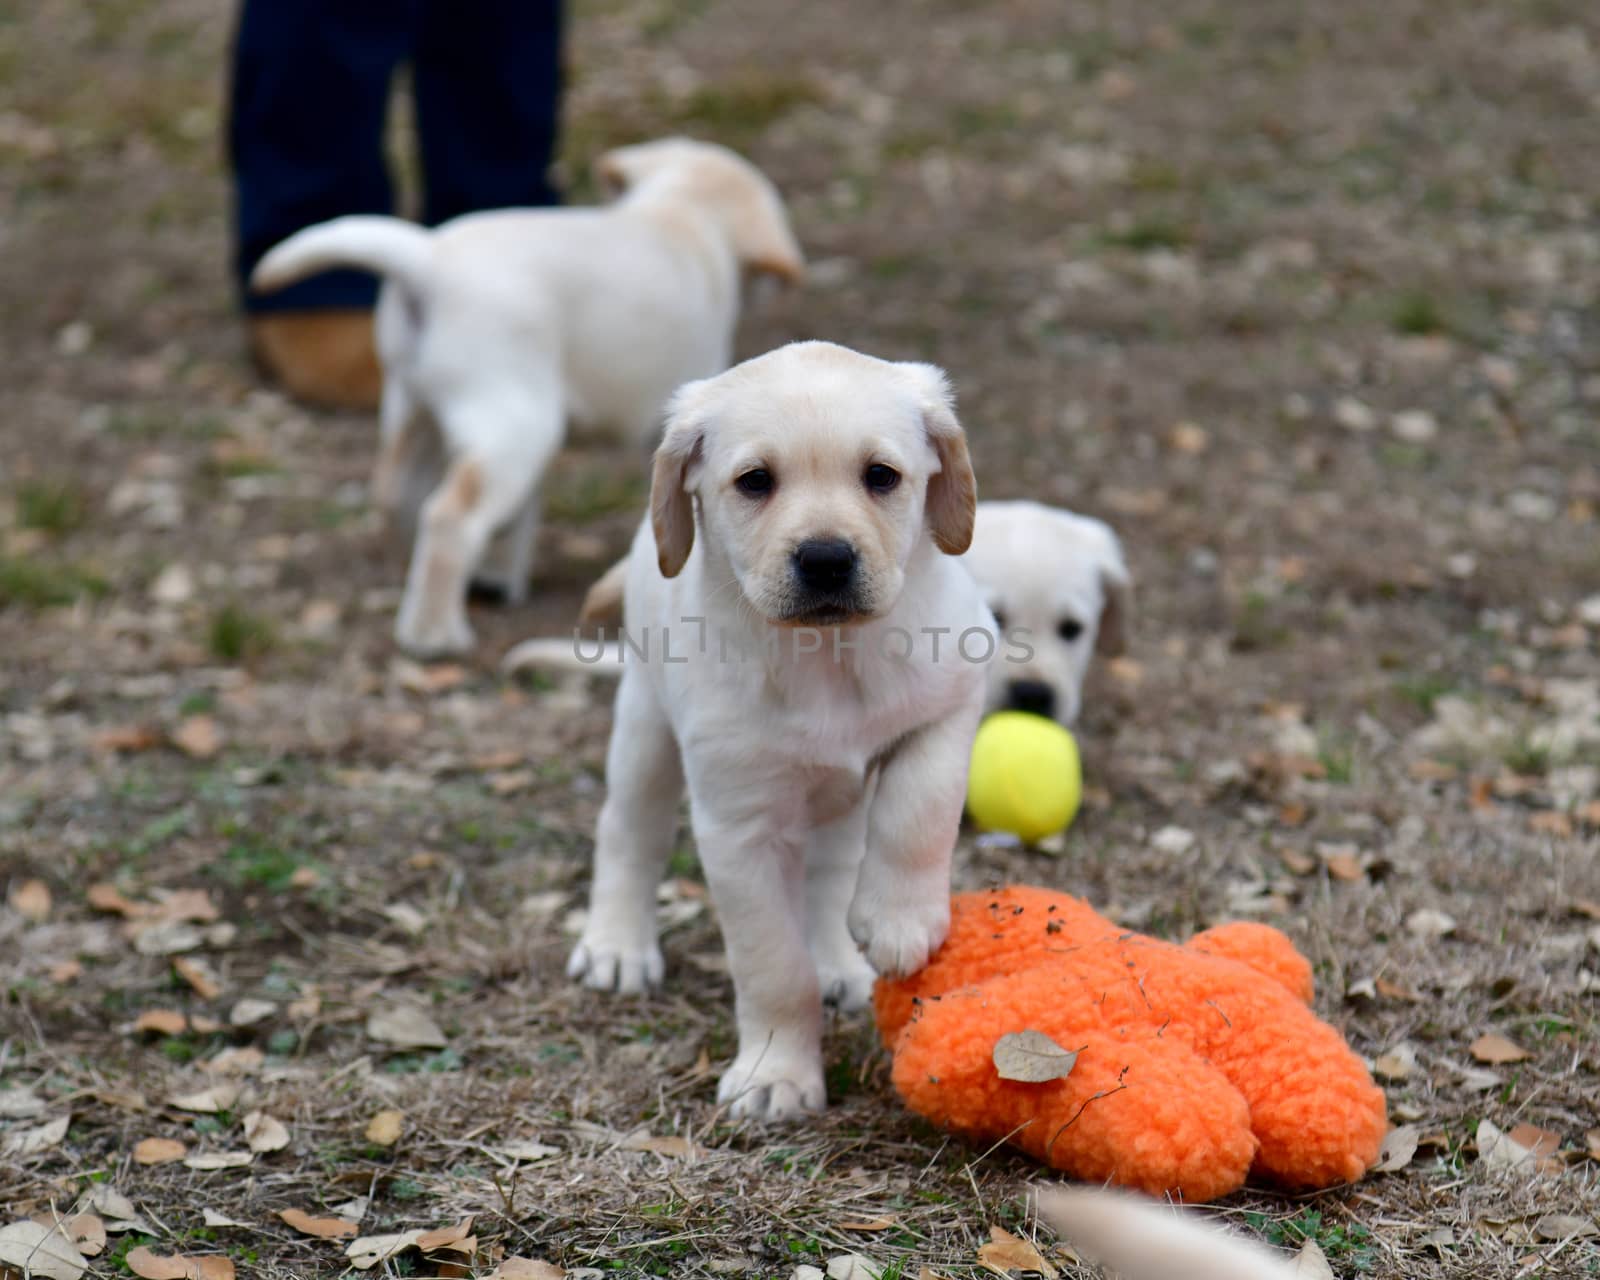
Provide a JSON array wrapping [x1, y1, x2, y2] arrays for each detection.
[[966, 710, 1083, 845]]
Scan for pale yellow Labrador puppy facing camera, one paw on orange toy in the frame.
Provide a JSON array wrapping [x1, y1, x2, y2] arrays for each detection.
[[568, 342, 995, 1120]]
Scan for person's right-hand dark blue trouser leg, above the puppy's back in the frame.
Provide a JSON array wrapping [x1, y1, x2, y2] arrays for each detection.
[[413, 0, 562, 226]]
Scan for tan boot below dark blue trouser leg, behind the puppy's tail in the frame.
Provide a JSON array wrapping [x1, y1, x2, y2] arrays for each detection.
[[250, 307, 384, 410]]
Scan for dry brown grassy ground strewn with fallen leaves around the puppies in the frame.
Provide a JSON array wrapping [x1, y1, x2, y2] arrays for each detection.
[[0, 0, 1600, 1280]]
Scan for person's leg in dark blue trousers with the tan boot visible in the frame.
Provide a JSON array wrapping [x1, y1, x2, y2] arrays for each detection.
[[227, 0, 421, 406]]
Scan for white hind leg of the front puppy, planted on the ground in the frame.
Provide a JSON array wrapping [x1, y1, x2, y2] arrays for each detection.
[[566, 666, 683, 992]]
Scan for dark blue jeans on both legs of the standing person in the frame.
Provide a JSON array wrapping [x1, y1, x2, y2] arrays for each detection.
[[227, 0, 562, 310]]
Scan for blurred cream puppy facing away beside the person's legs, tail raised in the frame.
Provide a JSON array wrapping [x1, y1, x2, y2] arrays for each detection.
[[251, 139, 803, 656]]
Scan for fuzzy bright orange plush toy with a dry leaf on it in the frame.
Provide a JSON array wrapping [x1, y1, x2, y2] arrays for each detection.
[[875, 888, 1387, 1202]]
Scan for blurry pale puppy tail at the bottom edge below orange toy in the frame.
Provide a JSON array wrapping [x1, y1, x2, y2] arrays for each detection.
[[1038, 1187, 1296, 1280]]
